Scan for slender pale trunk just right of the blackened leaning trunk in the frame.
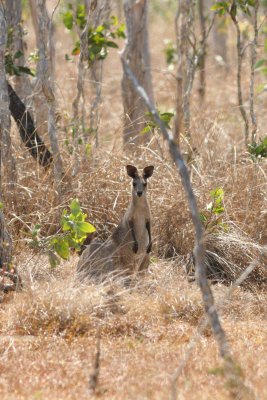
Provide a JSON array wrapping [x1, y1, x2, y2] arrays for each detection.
[[36, 0, 63, 194]]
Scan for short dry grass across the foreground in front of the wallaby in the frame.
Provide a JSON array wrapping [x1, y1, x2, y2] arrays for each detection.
[[0, 259, 267, 399]]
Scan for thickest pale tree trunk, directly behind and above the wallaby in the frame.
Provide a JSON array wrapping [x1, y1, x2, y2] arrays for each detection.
[[122, 0, 154, 144]]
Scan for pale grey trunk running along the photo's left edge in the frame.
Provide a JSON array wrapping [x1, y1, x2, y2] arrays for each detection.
[[0, 4, 17, 189]]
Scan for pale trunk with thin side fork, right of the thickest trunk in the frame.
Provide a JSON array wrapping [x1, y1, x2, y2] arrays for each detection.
[[173, 0, 215, 151]]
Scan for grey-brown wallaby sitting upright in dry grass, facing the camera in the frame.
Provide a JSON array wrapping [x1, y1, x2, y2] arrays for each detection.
[[77, 165, 154, 279]]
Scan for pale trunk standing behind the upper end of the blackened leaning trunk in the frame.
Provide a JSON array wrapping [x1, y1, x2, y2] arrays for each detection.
[[6, 0, 31, 105]]
